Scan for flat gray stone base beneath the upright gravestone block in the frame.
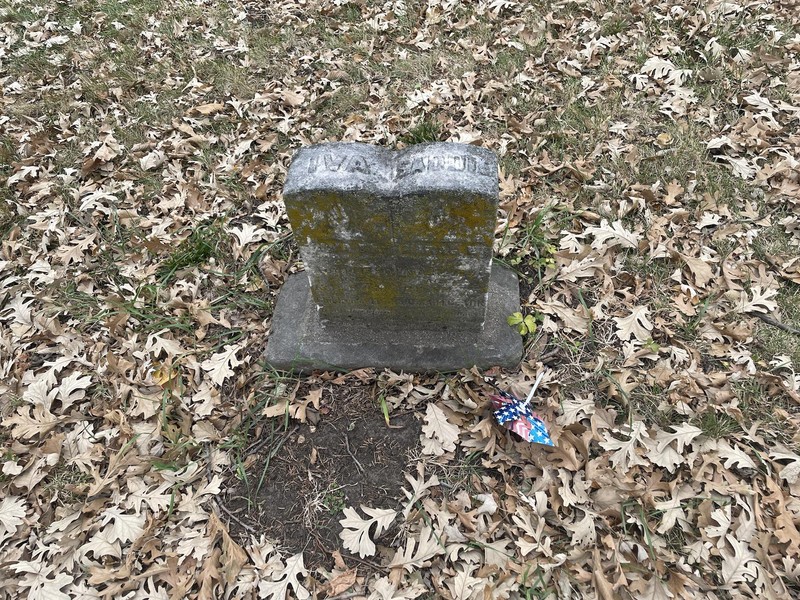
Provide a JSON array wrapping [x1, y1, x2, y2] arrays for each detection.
[[265, 263, 523, 372]]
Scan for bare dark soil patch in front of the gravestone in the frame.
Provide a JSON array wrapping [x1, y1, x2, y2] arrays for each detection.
[[223, 386, 421, 568]]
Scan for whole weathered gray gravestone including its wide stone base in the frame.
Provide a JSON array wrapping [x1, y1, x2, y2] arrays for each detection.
[[266, 143, 522, 371]]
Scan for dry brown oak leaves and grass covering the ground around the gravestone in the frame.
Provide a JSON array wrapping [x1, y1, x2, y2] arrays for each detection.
[[0, 0, 800, 600]]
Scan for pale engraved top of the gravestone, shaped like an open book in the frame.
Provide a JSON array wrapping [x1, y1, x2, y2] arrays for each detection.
[[283, 142, 498, 196]]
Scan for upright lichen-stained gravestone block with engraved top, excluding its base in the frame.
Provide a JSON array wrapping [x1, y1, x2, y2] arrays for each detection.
[[283, 143, 498, 330]]
